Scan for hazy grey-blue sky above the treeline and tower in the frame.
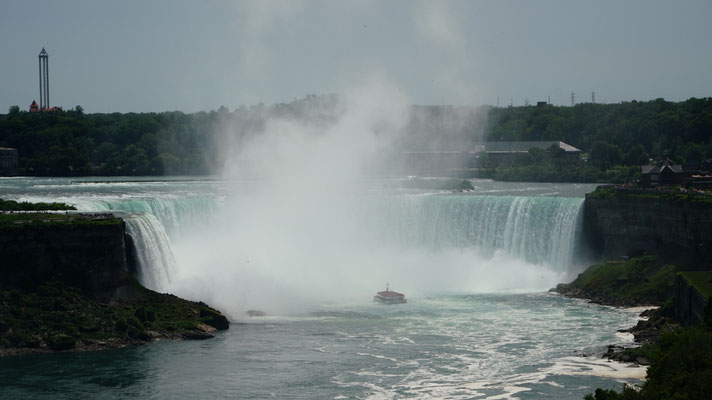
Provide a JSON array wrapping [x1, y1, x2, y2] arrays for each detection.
[[0, 0, 712, 113]]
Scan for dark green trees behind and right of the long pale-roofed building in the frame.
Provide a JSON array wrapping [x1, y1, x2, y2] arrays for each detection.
[[485, 98, 712, 166]]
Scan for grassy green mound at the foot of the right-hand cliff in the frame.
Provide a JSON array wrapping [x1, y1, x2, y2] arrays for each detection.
[[565, 256, 675, 305]]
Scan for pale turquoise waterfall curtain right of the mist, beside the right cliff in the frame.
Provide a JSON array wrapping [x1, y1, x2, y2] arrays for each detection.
[[367, 194, 584, 270]]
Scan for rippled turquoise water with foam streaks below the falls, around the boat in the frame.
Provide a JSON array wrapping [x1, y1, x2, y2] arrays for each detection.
[[0, 293, 635, 399]]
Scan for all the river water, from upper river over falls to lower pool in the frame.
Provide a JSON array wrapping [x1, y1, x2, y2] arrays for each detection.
[[0, 178, 644, 399]]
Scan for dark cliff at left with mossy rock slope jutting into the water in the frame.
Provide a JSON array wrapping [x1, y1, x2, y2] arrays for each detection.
[[0, 213, 229, 356]]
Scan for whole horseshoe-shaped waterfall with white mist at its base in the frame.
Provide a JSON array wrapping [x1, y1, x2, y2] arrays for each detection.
[[5, 177, 590, 307]]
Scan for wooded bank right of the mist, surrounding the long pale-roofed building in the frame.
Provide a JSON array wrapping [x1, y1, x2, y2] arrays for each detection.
[[471, 98, 712, 183]]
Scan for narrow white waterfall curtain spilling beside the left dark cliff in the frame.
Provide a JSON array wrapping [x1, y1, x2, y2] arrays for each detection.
[[117, 212, 176, 291]]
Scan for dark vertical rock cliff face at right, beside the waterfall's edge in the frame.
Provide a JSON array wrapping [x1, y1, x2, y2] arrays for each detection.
[[583, 187, 712, 267]]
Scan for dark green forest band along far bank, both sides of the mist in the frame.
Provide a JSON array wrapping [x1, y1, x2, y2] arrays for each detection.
[[0, 95, 712, 182]]
